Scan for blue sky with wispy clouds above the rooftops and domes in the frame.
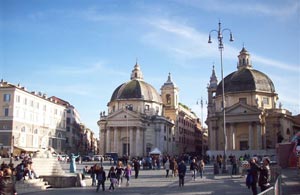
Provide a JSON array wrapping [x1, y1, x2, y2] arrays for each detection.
[[0, 0, 300, 137]]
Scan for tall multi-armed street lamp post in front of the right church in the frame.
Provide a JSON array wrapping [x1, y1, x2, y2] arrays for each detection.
[[208, 21, 233, 173]]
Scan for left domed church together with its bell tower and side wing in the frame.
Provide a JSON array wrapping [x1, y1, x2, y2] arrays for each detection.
[[98, 63, 205, 157]]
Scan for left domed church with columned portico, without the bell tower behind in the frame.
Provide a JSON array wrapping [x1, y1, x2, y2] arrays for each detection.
[[98, 63, 175, 156]]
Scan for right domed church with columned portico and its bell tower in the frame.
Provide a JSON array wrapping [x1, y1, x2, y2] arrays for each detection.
[[206, 47, 296, 154]]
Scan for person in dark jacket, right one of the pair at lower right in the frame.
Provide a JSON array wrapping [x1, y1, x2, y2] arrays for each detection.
[[258, 158, 271, 192]]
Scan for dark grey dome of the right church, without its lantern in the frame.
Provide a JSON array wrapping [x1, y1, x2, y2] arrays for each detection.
[[216, 68, 275, 95]]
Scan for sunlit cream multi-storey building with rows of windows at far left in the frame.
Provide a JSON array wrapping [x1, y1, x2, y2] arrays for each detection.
[[0, 80, 66, 155]]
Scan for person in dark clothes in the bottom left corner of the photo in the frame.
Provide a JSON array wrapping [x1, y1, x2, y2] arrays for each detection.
[[0, 168, 17, 195]]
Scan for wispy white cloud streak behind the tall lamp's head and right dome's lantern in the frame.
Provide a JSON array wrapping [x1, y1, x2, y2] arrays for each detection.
[[142, 16, 300, 72]]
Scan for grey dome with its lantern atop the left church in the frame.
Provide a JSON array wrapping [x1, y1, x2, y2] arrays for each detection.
[[110, 64, 162, 104]]
